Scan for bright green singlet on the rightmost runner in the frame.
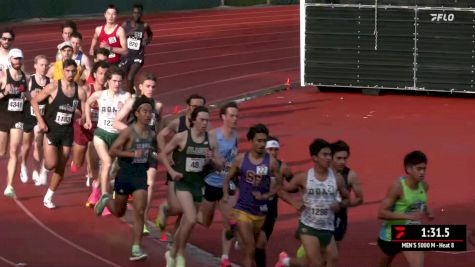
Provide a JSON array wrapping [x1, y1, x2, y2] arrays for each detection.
[[379, 177, 427, 241]]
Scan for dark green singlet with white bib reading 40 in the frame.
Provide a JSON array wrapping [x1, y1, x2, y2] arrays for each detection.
[[173, 130, 210, 185]]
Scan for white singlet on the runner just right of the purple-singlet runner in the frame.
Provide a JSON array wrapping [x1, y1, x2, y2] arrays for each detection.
[[300, 168, 338, 231]]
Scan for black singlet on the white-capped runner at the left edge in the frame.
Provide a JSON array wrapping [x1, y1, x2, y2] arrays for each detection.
[[0, 69, 28, 113]]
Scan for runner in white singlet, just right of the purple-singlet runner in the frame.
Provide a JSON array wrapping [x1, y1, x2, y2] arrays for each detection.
[[276, 139, 349, 266]]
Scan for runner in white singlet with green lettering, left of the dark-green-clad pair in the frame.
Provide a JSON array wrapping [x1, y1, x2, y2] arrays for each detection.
[[84, 66, 130, 199]]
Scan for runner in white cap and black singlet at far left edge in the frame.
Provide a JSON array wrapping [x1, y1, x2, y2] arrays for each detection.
[[0, 48, 28, 198]]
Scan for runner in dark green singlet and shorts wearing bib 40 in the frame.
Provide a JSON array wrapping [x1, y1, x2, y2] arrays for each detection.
[[160, 107, 224, 267]]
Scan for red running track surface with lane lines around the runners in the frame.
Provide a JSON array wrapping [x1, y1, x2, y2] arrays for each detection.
[[0, 6, 475, 267]]
